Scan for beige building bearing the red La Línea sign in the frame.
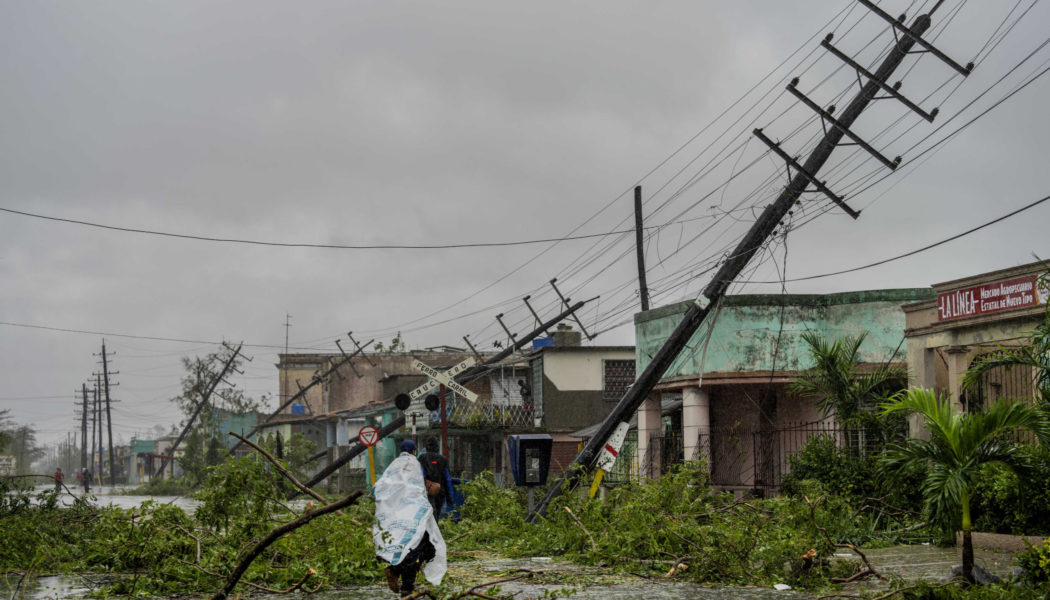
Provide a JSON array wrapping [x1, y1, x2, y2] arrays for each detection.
[[903, 263, 1050, 420]]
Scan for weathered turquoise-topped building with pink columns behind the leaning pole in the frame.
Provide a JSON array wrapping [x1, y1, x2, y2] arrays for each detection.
[[634, 289, 933, 490]]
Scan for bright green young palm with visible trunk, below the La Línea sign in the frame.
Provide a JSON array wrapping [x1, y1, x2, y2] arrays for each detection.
[[879, 388, 1050, 582]]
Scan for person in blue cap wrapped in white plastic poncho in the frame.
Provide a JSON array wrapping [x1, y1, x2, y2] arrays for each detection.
[[372, 440, 446, 596]]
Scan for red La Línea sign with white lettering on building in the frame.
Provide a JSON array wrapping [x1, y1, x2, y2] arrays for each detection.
[[937, 275, 1048, 320]]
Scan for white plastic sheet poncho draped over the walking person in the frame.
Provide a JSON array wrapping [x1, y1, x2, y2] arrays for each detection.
[[372, 453, 447, 585]]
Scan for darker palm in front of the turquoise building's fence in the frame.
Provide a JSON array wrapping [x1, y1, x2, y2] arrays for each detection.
[[790, 331, 907, 441]]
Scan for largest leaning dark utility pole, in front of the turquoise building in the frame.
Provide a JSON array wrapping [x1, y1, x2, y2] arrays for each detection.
[[526, 5, 961, 522]]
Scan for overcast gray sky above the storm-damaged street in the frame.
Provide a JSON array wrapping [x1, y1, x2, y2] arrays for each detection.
[[0, 0, 1050, 447]]
